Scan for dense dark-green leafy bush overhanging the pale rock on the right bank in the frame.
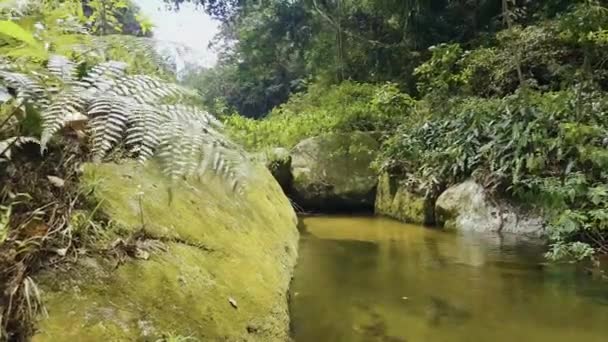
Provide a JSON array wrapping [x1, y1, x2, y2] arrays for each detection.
[[377, 89, 608, 255]]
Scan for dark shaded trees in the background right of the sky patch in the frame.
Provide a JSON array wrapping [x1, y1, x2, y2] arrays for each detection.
[[177, 0, 508, 117]]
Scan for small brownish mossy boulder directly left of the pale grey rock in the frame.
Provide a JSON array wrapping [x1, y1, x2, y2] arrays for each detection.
[[375, 173, 435, 224]]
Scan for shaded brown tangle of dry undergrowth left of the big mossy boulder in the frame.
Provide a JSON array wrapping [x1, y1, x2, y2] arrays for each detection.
[[0, 140, 89, 341]]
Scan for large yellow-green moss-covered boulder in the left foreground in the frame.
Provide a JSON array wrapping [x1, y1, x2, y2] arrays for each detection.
[[34, 163, 298, 342]]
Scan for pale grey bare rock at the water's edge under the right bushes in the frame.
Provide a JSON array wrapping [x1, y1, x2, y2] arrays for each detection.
[[435, 180, 546, 237]]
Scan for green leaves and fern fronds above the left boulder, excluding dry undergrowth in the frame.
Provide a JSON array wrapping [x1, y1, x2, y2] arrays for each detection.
[[0, 0, 249, 188]]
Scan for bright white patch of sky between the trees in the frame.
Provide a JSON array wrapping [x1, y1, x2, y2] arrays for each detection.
[[134, 0, 219, 70]]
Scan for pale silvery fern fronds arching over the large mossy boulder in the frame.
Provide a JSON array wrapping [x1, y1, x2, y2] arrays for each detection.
[[0, 56, 247, 190]]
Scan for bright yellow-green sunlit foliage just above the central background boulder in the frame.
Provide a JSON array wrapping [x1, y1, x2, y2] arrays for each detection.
[[226, 82, 416, 150]]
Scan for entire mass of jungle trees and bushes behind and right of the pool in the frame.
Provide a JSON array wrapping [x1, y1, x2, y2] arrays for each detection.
[[175, 0, 608, 260]]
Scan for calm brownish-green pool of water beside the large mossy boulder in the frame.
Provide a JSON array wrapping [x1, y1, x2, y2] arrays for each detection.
[[291, 217, 608, 342]]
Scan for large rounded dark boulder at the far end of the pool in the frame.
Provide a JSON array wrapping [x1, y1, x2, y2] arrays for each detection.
[[291, 132, 380, 211]]
